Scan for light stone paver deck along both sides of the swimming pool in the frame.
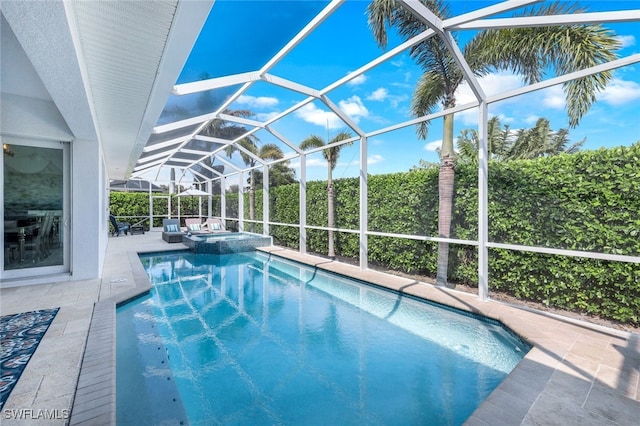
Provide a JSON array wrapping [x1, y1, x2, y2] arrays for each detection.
[[0, 231, 640, 425]]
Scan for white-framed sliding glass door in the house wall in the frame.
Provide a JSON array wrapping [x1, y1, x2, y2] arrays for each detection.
[[2, 137, 69, 278]]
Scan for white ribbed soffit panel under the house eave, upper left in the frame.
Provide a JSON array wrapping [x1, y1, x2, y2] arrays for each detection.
[[71, 0, 213, 179]]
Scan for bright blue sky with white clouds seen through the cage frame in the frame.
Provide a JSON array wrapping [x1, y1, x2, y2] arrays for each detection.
[[169, 0, 640, 185]]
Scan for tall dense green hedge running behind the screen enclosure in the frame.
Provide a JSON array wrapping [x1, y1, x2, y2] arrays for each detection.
[[112, 143, 640, 325]]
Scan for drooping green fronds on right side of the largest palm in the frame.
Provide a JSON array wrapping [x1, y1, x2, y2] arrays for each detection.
[[465, 2, 620, 127]]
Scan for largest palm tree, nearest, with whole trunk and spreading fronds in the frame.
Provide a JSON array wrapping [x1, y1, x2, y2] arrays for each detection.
[[367, 0, 620, 287]]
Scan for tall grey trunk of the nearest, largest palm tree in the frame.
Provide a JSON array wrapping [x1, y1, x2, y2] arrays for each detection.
[[436, 114, 456, 288]]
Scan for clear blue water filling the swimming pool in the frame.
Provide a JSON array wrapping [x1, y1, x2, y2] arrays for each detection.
[[116, 252, 529, 425]]
